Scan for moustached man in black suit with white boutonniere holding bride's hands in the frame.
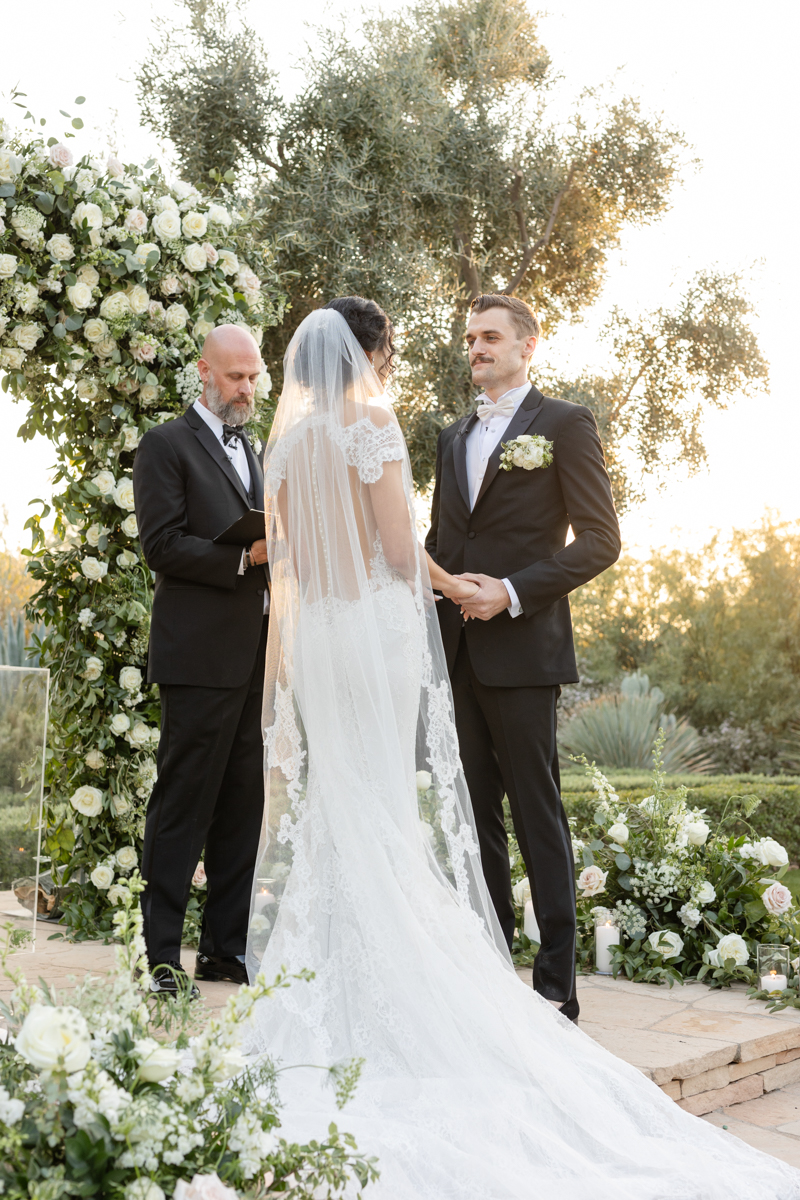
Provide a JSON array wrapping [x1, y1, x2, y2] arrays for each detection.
[[426, 295, 620, 1020]]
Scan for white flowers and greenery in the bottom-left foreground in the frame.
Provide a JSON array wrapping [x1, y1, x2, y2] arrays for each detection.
[[0, 876, 378, 1200]]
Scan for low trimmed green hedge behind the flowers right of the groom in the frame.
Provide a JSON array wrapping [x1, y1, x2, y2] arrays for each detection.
[[561, 770, 800, 863]]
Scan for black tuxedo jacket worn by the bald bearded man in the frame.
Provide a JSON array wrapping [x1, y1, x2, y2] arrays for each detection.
[[133, 408, 266, 688]]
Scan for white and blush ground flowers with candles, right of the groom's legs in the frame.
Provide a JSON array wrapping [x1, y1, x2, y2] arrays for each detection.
[[510, 733, 800, 988]]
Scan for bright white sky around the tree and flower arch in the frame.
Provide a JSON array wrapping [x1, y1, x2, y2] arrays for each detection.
[[0, 0, 800, 554]]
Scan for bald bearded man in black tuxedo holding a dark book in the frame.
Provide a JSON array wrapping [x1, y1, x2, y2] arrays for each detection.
[[133, 325, 269, 995]]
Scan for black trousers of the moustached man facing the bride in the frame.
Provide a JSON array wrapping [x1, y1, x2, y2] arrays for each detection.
[[452, 632, 578, 1018]]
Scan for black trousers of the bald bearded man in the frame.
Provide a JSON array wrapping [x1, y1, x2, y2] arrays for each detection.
[[142, 617, 267, 966]]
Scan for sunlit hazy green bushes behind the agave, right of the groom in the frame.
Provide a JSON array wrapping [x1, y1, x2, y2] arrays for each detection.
[[572, 520, 800, 774]]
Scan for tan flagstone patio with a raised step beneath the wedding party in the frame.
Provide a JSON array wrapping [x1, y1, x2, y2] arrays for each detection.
[[0, 892, 800, 1168]]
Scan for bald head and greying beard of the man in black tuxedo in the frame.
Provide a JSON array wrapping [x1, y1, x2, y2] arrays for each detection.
[[197, 325, 264, 425]]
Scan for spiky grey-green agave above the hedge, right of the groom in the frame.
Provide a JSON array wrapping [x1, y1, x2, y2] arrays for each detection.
[[559, 671, 714, 774]]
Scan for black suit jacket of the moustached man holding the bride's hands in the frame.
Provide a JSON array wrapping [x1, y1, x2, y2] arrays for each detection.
[[426, 386, 621, 688]]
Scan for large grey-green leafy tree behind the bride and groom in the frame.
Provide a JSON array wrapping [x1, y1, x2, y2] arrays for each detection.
[[138, 0, 765, 508]]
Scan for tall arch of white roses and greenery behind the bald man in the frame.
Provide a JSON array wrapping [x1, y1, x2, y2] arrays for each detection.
[[0, 94, 284, 937]]
